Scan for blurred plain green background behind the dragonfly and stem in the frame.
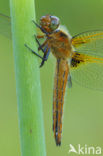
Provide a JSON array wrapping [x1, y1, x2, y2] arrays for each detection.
[[0, 0, 103, 156]]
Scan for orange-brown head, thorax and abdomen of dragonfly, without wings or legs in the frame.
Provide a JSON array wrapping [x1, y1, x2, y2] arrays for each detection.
[[38, 15, 72, 145]]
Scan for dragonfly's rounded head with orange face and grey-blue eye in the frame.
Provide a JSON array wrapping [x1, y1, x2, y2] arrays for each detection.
[[40, 15, 60, 33]]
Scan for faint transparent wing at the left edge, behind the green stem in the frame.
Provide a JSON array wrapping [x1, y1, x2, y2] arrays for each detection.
[[0, 13, 11, 39]]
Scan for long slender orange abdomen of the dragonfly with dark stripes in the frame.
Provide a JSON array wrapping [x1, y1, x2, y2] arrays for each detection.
[[53, 59, 69, 145]]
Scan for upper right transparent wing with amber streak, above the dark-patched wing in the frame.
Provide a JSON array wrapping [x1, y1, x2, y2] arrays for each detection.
[[72, 30, 103, 57]]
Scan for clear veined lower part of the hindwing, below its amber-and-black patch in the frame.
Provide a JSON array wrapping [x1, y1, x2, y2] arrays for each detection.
[[71, 63, 103, 91]]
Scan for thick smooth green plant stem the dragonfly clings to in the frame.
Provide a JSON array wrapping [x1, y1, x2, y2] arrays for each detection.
[[10, 0, 46, 156]]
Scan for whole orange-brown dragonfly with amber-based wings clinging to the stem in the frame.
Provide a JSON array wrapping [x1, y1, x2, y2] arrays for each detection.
[[0, 14, 103, 146]]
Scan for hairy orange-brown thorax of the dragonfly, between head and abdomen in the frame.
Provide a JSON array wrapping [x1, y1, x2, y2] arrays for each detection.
[[48, 30, 72, 59]]
